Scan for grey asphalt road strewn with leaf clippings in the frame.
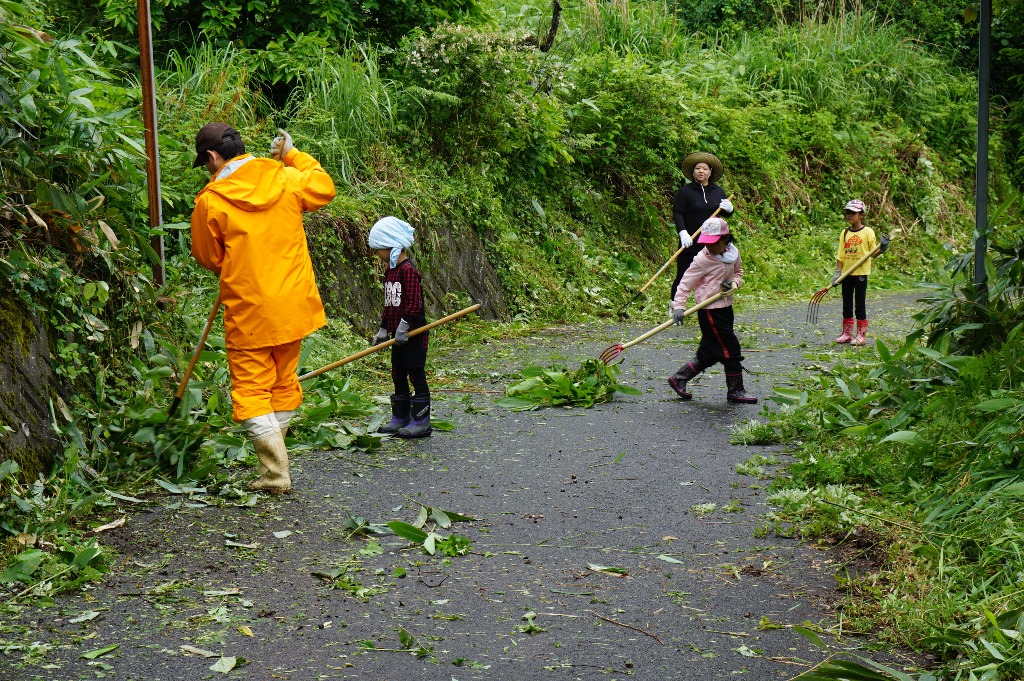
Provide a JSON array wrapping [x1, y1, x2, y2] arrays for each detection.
[[0, 295, 912, 681]]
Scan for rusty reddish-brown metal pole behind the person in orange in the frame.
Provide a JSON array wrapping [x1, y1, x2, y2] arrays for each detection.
[[138, 0, 165, 286]]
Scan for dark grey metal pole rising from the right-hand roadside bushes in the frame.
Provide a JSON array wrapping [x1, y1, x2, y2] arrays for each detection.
[[974, 0, 992, 292]]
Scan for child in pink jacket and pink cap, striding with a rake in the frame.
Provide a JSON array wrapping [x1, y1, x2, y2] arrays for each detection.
[[669, 217, 758, 405]]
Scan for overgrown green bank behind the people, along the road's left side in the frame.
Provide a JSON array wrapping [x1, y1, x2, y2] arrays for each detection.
[[0, 0, 1019, 675]]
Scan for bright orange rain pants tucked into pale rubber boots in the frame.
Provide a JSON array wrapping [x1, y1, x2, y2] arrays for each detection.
[[227, 339, 302, 421]]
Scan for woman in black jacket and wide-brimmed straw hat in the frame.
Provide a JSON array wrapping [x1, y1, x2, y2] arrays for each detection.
[[669, 152, 732, 300]]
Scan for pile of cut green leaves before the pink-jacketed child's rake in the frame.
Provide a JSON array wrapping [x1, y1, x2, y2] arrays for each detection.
[[495, 359, 640, 412]]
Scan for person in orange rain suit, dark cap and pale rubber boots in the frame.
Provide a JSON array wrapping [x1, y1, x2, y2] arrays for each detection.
[[191, 123, 335, 493]]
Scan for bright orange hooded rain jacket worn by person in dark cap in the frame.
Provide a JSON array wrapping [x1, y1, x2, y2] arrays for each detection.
[[191, 148, 335, 349]]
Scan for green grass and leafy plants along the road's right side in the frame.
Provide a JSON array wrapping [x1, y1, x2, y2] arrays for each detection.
[[757, 196, 1024, 680]]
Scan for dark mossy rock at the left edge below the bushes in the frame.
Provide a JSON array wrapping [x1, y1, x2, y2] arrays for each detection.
[[0, 287, 59, 480]]
